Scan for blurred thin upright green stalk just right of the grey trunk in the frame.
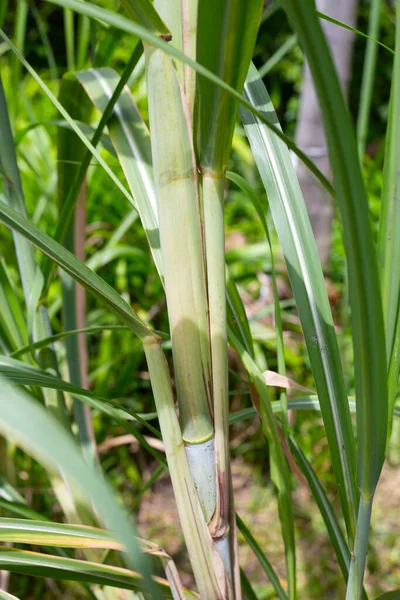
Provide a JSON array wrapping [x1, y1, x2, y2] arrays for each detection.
[[357, 0, 381, 160]]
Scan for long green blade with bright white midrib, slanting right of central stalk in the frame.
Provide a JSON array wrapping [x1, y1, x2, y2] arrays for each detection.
[[241, 67, 358, 540]]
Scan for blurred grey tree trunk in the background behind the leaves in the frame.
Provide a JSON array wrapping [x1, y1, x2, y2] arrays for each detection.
[[296, 0, 358, 266]]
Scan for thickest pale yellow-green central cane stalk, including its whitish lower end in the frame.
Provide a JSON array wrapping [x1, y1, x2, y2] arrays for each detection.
[[145, 46, 219, 522]]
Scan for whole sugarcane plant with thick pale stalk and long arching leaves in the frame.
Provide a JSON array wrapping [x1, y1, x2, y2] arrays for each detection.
[[0, 0, 400, 600]]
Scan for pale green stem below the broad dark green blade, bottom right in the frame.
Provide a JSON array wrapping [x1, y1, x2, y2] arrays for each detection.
[[346, 496, 373, 600]]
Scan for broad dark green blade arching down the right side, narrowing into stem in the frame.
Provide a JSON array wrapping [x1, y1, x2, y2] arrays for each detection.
[[283, 0, 387, 499]]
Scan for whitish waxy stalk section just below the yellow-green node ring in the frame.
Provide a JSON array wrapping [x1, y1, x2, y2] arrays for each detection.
[[185, 438, 216, 523]]
